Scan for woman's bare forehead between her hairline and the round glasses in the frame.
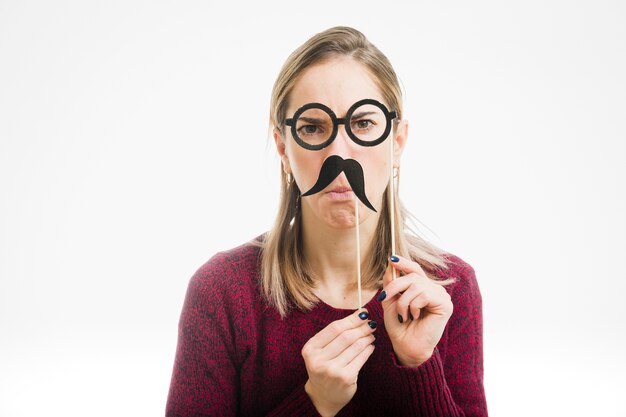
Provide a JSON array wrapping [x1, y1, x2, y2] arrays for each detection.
[[287, 58, 384, 116]]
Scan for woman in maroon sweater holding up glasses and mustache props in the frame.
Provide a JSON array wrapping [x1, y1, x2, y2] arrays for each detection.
[[167, 27, 487, 416]]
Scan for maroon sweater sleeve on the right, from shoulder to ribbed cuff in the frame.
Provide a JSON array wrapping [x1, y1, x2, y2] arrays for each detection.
[[392, 261, 487, 417]]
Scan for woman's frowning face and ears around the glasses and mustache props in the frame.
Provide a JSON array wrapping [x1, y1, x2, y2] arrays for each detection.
[[274, 58, 407, 228]]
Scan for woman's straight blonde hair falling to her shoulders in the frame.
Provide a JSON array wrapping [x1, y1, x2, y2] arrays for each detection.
[[260, 26, 450, 317]]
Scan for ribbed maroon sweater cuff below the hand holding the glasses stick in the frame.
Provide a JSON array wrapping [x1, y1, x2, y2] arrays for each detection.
[[391, 348, 463, 417]]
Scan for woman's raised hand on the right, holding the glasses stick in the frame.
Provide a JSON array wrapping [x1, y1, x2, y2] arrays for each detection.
[[379, 256, 452, 366]]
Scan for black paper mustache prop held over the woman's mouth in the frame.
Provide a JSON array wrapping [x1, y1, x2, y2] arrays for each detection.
[[302, 155, 376, 212]]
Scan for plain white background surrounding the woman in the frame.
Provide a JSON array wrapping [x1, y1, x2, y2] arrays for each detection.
[[0, 0, 626, 417]]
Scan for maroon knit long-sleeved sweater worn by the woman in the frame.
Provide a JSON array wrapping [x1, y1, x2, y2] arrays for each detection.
[[166, 239, 487, 417]]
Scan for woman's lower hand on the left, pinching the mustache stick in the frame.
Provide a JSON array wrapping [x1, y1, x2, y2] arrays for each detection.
[[302, 310, 376, 417]]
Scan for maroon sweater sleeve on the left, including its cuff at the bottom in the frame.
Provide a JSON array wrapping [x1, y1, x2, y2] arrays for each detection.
[[166, 255, 319, 417]]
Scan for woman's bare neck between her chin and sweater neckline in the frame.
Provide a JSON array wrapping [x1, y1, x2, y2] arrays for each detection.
[[302, 203, 378, 308]]
